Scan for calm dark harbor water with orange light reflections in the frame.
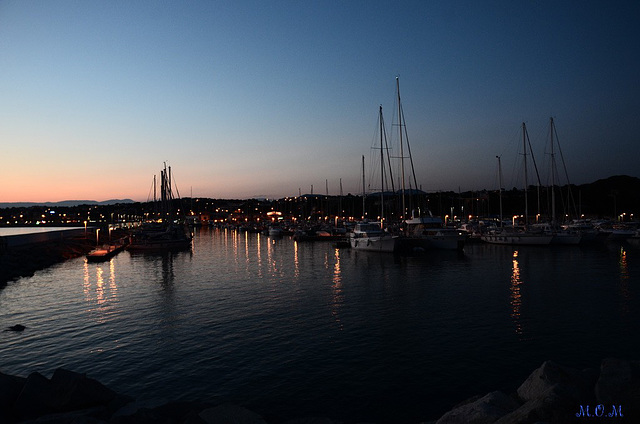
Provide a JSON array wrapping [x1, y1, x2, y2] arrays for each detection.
[[0, 229, 640, 422]]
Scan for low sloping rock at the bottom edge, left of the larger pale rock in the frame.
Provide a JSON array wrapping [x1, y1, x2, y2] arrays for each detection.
[[436, 391, 520, 424]]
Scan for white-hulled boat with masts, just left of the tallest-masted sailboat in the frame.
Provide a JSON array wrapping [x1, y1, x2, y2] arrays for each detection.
[[349, 106, 398, 253]]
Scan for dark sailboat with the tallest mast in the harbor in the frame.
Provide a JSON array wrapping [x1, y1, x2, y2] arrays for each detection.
[[396, 77, 466, 250]]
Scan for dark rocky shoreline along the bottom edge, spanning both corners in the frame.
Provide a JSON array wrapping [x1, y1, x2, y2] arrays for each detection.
[[0, 358, 640, 424]]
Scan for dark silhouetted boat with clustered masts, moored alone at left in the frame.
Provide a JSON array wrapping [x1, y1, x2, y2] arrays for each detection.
[[127, 163, 191, 252]]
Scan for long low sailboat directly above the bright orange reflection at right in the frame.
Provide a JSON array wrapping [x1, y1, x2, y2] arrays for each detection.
[[480, 122, 553, 246]]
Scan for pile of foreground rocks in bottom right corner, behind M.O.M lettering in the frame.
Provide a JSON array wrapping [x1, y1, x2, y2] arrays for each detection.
[[437, 359, 640, 424]]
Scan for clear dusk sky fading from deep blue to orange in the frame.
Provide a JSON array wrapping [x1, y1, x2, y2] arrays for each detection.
[[0, 0, 640, 202]]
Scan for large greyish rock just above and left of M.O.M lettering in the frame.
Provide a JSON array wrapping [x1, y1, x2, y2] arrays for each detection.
[[518, 361, 597, 402]]
